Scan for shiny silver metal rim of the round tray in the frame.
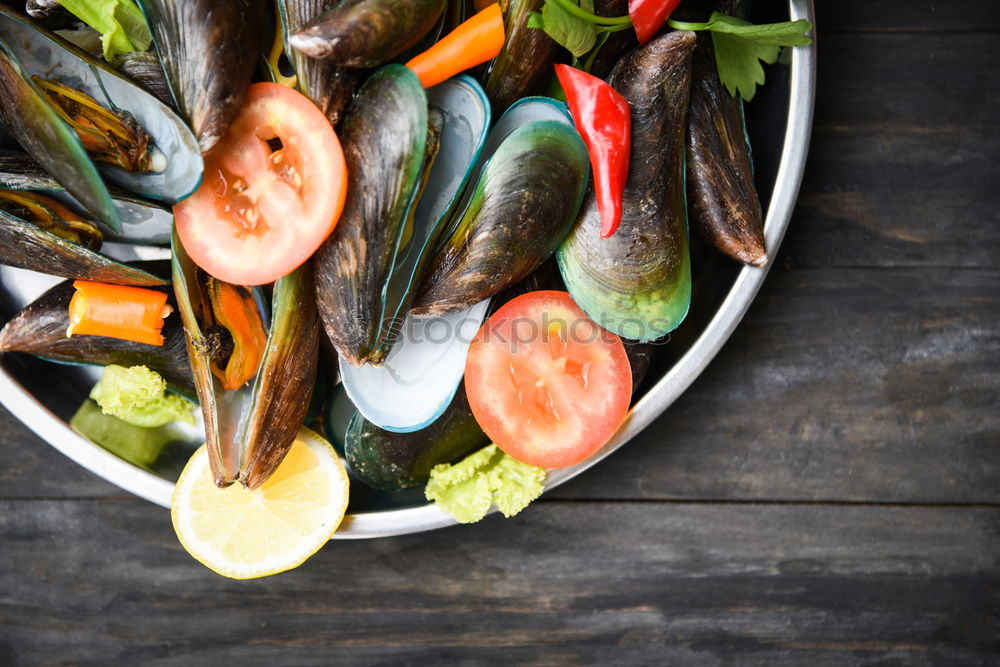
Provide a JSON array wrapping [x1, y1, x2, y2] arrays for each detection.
[[0, 0, 816, 539]]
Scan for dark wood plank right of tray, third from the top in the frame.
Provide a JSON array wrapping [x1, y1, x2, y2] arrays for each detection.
[[554, 269, 1000, 503]]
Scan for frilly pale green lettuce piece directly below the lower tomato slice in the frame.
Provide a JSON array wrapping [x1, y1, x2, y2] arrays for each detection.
[[424, 445, 545, 523]]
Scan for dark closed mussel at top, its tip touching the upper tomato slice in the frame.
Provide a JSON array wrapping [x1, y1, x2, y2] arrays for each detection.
[[138, 0, 264, 151]]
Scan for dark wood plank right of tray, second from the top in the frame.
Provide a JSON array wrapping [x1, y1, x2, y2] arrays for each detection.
[[780, 32, 1000, 268]]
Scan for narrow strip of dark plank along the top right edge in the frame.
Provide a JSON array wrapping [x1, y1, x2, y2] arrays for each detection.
[[815, 0, 1000, 32]]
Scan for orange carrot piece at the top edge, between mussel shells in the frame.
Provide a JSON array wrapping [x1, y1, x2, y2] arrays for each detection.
[[406, 3, 505, 88]]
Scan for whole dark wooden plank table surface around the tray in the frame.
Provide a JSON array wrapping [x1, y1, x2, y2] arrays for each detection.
[[0, 0, 1000, 665]]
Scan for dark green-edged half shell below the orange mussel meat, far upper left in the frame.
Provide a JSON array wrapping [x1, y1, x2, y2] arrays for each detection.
[[0, 31, 121, 230]]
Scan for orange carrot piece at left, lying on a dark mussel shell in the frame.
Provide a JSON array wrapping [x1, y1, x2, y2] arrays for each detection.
[[66, 280, 172, 345]]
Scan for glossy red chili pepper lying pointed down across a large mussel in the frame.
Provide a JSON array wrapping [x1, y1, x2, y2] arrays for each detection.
[[555, 65, 632, 238]]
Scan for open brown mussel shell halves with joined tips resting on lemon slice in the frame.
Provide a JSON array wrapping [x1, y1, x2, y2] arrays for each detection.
[[172, 235, 320, 489]]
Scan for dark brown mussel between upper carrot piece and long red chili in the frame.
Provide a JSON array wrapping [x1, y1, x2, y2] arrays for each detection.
[[483, 0, 559, 114]]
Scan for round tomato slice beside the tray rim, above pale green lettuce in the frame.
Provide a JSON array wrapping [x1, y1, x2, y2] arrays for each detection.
[[465, 291, 632, 468]]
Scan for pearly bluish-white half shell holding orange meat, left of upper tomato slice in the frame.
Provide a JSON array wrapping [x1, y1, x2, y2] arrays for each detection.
[[0, 6, 203, 205]]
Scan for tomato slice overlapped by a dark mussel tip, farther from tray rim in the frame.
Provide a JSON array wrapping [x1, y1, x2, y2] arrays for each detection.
[[174, 83, 347, 285]]
